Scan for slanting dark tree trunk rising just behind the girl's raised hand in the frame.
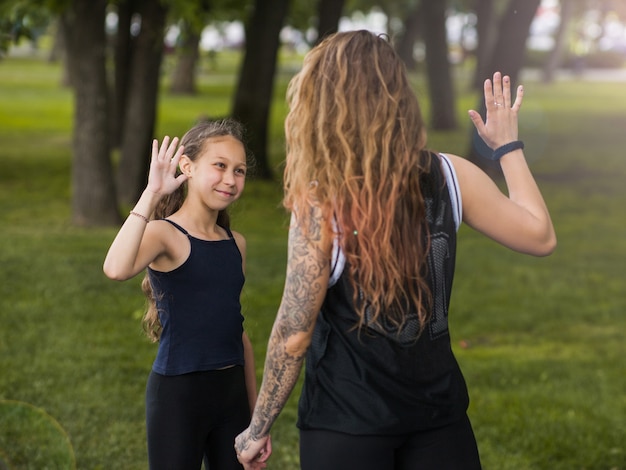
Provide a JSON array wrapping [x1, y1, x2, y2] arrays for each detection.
[[117, 0, 167, 205]]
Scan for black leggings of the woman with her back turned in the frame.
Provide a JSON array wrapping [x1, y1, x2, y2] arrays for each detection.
[[300, 416, 481, 470]]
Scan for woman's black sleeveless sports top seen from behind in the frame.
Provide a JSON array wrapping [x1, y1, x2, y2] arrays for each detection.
[[298, 154, 469, 435]]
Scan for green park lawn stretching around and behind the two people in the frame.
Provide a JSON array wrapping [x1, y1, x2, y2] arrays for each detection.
[[0, 56, 626, 470]]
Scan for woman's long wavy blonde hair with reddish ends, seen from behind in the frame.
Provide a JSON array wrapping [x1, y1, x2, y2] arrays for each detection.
[[283, 31, 431, 331]]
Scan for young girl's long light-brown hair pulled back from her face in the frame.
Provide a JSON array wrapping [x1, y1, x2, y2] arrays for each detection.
[[141, 118, 254, 342]]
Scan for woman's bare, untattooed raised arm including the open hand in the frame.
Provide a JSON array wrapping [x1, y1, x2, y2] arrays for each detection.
[[451, 73, 556, 256]]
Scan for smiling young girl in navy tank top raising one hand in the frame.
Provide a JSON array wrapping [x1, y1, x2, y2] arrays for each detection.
[[104, 120, 268, 470]]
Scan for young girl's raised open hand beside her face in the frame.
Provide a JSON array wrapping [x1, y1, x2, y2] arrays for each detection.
[[146, 136, 187, 196]]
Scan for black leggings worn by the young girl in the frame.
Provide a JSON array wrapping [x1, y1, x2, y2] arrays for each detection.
[[146, 366, 250, 470]]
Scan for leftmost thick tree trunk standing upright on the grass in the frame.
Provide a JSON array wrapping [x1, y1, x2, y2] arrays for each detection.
[[62, 0, 120, 226]]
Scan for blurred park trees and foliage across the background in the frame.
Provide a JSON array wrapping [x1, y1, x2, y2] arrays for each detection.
[[0, 0, 626, 225]]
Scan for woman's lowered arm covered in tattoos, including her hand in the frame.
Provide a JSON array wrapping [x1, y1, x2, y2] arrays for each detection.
[[235, 208, 331, 470]]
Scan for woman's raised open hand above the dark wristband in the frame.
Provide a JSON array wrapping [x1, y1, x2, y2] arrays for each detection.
[[469, 72, 524, 149]]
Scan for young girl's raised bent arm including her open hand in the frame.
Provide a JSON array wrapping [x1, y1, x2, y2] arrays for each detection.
[[103, 137, 186, 281]]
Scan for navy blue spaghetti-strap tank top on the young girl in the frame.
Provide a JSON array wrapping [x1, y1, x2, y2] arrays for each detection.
[[148, 219, 244, 375]]
